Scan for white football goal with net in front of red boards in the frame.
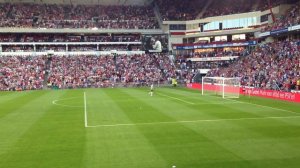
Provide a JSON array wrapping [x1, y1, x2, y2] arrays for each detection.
[[202, 77, 241, 98]]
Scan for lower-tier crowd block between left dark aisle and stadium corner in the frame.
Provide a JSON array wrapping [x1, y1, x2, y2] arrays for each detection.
[[48, 54, 175, 88]]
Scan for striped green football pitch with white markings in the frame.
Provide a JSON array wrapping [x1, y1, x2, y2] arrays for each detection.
[[0, 88, 300, 168]]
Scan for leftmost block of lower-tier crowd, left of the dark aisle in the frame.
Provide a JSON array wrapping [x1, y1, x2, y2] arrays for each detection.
[[0, 56, 46, 91]]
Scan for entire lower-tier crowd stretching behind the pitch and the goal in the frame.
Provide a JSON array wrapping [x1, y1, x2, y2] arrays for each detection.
[[0, 40, 300, 91]]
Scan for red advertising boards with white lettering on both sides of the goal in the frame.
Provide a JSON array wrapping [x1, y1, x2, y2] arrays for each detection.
[[187, 83, 300, 103]]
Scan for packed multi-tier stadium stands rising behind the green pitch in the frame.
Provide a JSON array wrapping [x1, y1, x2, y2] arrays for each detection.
[[0, 0, 300, 91]]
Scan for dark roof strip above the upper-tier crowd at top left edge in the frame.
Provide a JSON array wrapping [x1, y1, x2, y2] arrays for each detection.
[[0, 0, 153, 5]]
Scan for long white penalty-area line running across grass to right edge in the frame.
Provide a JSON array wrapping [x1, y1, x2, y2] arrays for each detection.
[[87, 115, 300, 128]]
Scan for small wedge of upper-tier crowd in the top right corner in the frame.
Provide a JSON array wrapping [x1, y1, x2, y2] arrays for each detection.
[[263, 4, 300, 31]]
